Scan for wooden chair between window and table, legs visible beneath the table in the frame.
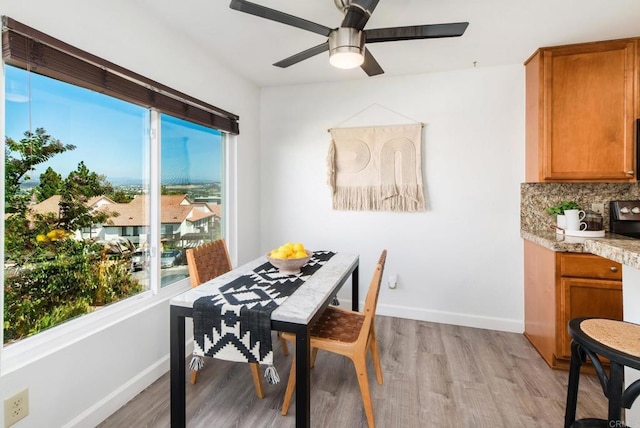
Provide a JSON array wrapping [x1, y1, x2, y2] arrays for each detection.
[[187, 239, 289, 398]]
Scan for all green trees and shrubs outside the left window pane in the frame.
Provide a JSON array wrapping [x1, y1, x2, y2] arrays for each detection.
[[4, 128, 143, 342]]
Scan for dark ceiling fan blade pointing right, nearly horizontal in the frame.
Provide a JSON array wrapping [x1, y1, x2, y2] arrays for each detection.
[[365, 22, 469, 43]]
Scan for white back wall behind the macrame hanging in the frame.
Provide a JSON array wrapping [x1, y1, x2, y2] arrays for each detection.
[[260, 65, 525, 332]]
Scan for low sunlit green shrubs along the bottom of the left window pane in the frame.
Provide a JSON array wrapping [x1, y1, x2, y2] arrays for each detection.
[[4, 238, 143, 341]]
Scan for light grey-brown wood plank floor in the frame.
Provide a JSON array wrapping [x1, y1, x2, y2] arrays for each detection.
[[99, 316, 607, 428]]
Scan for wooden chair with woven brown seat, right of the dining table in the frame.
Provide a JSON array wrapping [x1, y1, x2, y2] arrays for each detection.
[[282, 250, 387, 428]]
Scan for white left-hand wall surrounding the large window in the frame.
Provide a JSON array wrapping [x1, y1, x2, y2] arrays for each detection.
[[0, 0, 260, 427]]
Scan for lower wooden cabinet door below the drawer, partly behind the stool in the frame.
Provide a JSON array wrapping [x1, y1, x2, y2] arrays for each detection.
[[556, 278, 622, 359]]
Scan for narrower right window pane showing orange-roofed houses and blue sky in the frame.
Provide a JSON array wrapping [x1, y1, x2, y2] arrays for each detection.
[[160, 114, 223, 287]]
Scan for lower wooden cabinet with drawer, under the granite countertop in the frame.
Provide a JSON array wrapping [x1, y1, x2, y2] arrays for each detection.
[[524, 240, 622, 369]]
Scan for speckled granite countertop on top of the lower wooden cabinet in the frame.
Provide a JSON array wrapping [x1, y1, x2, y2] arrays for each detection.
[[520, 229, 640, 269]]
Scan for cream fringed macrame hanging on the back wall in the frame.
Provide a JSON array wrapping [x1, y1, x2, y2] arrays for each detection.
[[327, 105, 425, 211]]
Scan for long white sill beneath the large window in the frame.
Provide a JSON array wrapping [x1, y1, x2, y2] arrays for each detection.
[[0, 278, 190, 375]]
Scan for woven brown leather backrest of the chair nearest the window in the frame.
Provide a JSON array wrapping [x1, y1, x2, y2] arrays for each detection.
[[187, 239, 231, 288]]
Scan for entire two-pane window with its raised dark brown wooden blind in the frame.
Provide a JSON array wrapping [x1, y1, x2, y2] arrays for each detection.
[[3, 18, 238, 344]]
